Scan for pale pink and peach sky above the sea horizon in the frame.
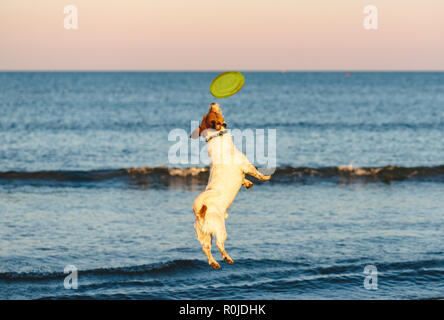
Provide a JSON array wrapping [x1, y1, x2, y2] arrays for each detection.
[[0, 0, 444, 71]]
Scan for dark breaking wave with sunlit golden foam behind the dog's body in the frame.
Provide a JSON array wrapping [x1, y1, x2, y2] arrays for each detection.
[[0, 165, 444, 186]]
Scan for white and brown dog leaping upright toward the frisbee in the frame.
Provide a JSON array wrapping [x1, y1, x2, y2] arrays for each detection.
[[190, 103, 271, 269]]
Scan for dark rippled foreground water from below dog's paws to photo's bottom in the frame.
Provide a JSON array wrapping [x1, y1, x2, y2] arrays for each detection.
[[0, 257, 444, 300]]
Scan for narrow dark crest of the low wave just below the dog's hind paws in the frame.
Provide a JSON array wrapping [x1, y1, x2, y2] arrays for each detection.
[[0, 258, 444, 282]]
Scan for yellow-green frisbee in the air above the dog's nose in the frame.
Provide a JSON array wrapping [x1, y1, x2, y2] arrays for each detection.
[[210, 71, 245, 98]]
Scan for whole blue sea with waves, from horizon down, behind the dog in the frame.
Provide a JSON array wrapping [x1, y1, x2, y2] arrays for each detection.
[[0, 72, 444, 299]]
